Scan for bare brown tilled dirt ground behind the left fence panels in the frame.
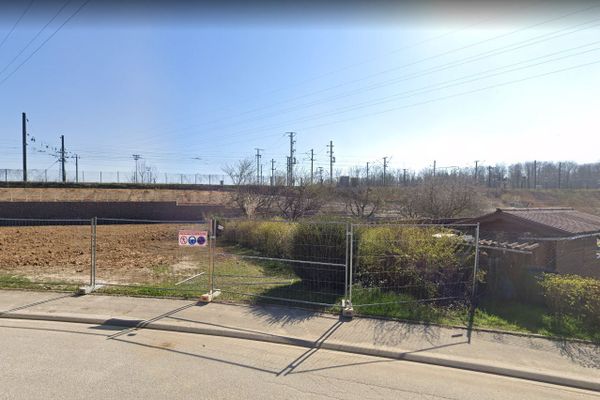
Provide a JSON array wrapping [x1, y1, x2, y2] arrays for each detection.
[[0, 224, 208, 283]]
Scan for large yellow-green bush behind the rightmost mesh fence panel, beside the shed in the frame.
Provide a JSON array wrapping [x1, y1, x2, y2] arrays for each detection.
[[354, 225, 473, 298]]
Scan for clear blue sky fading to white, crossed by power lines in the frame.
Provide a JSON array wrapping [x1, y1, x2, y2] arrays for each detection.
[[0, 0, 600, 182]]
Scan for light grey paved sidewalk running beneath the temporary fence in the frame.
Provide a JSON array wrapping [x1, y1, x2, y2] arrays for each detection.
[[0, 290, 600, 391]]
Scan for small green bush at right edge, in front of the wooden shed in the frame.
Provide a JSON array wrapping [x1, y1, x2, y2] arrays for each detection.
[[540, 274, 600, 328]]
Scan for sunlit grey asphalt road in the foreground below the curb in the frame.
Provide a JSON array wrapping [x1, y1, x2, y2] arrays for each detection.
[[0, 319, 600, 400]]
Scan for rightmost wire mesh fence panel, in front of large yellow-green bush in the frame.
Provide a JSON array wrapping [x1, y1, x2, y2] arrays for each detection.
[[348, 224, 478, 317]]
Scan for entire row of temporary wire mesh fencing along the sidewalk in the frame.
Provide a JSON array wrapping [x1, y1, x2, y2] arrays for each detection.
[[0, 218, 479, 315]]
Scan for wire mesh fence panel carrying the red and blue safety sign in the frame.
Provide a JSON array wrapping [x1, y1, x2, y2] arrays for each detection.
[[95, 218, 210, 294]]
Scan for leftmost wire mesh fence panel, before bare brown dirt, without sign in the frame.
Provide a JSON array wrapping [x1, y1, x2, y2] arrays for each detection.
[[0, 218, 91, 287]]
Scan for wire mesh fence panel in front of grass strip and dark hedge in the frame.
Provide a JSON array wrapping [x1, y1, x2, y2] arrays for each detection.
[[214, 219, 348, 306]]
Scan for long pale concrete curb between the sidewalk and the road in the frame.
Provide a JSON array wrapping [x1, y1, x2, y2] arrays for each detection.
[[0, 312, 600, 391]]
